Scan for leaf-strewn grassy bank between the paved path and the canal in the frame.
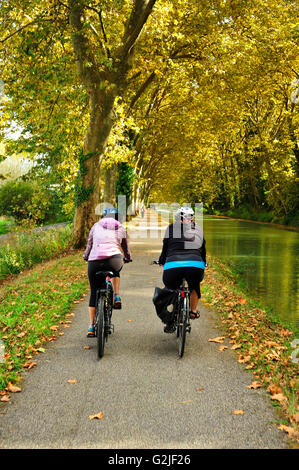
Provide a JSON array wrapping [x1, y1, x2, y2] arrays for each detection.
[[202, 255, 299, 442]]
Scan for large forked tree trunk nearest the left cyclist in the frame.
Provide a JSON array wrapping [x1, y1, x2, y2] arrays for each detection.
[[69, 0, 156, 248]]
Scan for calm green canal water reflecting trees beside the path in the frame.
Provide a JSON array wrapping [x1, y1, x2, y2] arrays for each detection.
[[203, 216, 299, 326]]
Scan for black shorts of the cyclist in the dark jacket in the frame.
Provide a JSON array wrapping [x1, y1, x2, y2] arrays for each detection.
[[163, 266, 205, 299]]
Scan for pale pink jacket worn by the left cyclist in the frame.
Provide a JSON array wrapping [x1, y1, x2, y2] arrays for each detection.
[[83, 217, 132, 261]]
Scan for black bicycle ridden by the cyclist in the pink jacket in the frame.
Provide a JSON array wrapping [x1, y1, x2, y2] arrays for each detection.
[[94, 271, 114, 359]]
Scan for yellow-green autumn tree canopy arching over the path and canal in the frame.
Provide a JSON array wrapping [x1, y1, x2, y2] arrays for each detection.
[[0, 0, 299, 235]]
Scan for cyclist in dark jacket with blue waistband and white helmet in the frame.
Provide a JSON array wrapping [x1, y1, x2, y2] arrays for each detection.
[[159, 207, 206, 333]]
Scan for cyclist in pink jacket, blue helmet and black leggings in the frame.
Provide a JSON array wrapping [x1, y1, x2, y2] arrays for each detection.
[[83, 208, 132, 337]]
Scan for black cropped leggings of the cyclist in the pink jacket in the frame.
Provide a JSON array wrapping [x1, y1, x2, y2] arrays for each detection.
[[88, 255, 123, 307]]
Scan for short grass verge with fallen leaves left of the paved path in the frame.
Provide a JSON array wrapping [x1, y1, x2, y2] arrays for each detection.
[[0, 251, 88, 394]]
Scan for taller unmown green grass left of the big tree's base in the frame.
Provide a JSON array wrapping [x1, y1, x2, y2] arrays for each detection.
[[0, 225, 72, 281]]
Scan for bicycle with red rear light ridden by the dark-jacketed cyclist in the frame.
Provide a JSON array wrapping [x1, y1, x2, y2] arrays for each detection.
[[151, 261, 191, 357]]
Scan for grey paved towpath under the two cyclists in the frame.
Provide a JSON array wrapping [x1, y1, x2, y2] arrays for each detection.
[[0, 213, 287, 449]]
